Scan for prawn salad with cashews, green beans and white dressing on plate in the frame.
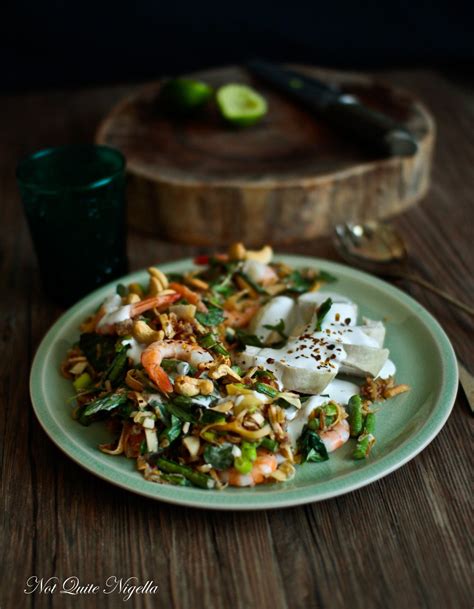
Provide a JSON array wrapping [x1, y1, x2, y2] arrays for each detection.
[[61, 243, 409, 489]]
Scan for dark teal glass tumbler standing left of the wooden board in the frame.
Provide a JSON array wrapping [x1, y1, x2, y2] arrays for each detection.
[[16, 144, 128, 305]]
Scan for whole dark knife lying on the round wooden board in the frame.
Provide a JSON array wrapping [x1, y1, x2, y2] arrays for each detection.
[[247, 60, 418, 156]]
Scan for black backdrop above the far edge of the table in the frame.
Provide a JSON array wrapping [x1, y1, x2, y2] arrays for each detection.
[[0, 0, 474, 90]]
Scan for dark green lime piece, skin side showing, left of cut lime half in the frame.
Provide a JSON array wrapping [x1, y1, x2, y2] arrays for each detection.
[[160, 78, 213, 114]]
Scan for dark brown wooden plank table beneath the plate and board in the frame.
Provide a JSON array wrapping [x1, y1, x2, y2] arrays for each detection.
[[0, 71, 474, 609]]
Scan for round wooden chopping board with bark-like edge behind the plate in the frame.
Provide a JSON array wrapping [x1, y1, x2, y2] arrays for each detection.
[[96, 66, 435, 246]]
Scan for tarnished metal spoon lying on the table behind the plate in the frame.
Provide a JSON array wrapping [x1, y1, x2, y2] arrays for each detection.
[[335, 221, 474, 316]]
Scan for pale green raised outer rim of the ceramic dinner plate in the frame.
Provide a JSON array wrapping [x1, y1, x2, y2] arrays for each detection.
[[29, 254, 458, 511]]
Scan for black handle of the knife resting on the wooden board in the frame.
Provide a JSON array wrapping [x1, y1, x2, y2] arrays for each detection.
[[321, 97, 418, 156]]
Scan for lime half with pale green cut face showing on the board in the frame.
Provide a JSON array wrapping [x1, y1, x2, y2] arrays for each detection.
[[216, 84, 267, 127]]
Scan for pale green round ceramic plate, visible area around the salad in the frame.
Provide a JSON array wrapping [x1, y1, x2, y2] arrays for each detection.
[[30, 256, 458, 510]]
